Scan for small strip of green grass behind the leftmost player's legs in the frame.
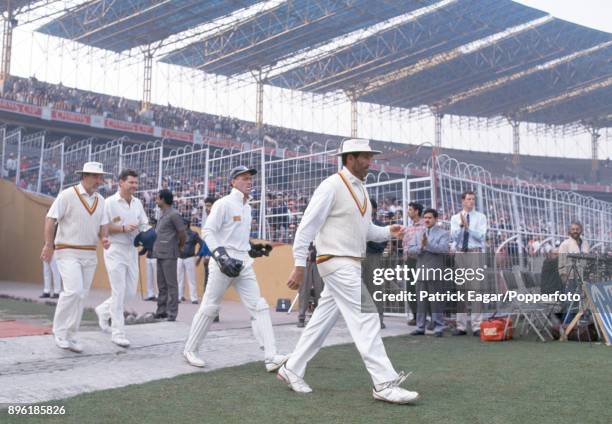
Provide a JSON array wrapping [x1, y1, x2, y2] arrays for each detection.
[[0, 297, 98, 326]]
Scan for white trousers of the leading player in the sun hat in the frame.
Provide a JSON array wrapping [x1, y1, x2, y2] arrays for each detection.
[[286, 261, 398, 384]]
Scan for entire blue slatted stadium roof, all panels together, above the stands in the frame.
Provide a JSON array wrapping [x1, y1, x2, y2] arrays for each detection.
[[34, 0, 612, 126]]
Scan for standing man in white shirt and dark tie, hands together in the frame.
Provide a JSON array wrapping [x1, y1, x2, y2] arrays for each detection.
[[451, 191, 488, 337]]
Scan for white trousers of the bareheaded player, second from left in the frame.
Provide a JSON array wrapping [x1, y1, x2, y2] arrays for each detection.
[[98, 243, 139, 336]]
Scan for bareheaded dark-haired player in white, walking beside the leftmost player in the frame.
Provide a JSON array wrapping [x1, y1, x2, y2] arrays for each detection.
[[95, 169, 150, 347]]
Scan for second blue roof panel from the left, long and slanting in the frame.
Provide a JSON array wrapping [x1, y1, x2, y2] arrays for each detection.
[[162, 0, 435, 75]]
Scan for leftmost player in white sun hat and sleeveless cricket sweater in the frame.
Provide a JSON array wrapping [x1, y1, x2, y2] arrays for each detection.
[[40, 162, 110, 353]]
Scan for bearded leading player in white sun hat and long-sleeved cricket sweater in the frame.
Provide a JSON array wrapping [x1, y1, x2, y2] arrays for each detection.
[[278, 139, 419, 404]]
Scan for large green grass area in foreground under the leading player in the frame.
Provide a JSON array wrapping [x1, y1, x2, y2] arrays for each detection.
[[0, 337, 612, 424]]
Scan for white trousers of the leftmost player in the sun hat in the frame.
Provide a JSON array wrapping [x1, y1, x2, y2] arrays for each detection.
[[53, 249, 98, 339]]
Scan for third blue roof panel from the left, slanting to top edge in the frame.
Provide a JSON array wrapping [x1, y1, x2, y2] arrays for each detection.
[[270, 0, 544, 93]]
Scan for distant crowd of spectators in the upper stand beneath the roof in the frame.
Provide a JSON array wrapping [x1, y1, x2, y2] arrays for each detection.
[[2, 77, 612, 187]]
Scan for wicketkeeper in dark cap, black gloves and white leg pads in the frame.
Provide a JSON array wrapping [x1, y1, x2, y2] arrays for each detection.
[[183, 166, 286, 372]]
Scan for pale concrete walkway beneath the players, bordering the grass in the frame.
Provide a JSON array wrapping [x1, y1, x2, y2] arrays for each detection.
[[0, 282, 411, 404]]
